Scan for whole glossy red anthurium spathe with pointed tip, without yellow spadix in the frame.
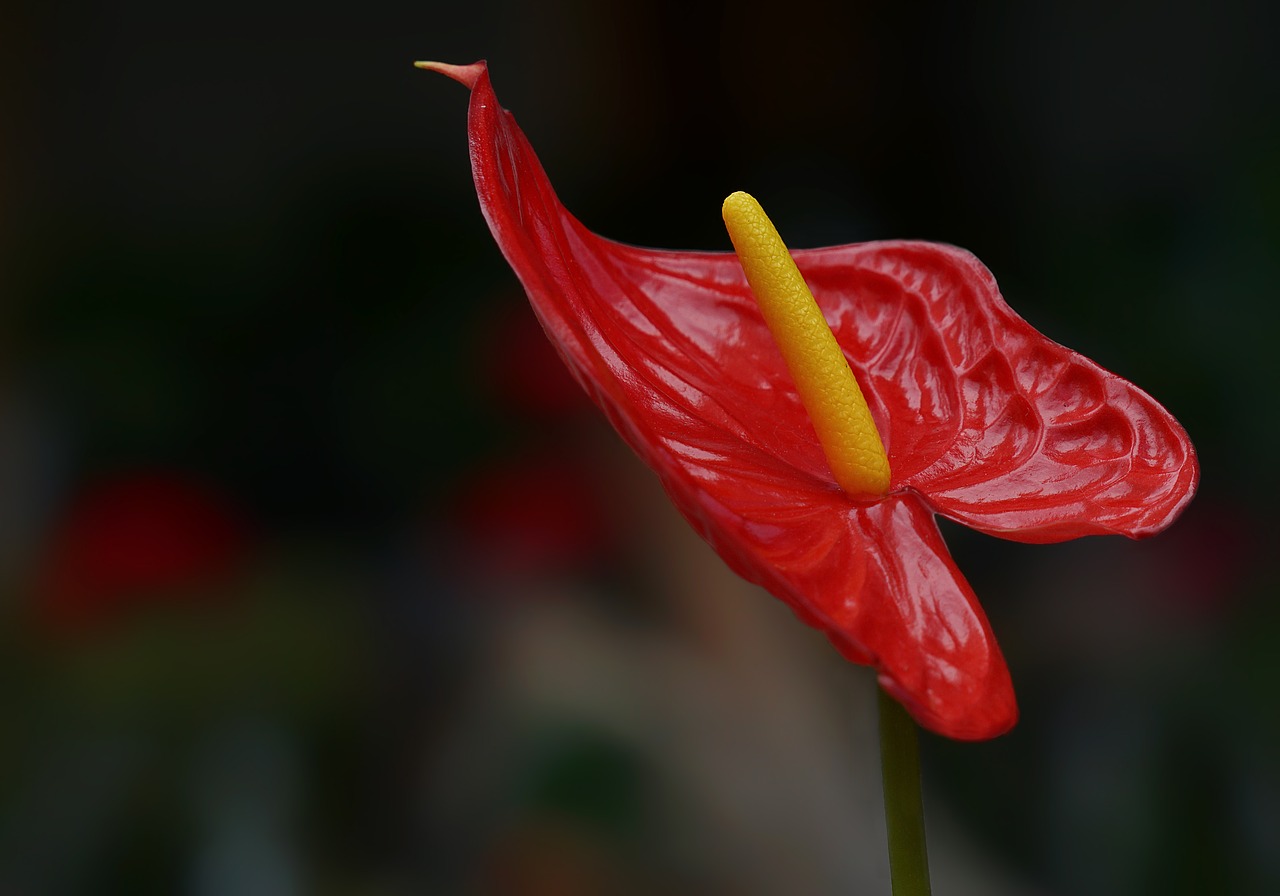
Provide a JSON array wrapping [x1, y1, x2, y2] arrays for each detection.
[[422, 63, 1198, 740]]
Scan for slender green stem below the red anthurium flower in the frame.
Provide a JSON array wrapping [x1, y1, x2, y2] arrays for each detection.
[[879, 689, 929, 896]]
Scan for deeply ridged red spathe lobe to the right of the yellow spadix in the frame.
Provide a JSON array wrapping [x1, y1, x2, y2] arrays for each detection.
[[773, 242, 1199, 541]]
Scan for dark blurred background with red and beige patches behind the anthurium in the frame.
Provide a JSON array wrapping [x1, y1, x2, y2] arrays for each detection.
[[0, 0, 1280, 896]]
